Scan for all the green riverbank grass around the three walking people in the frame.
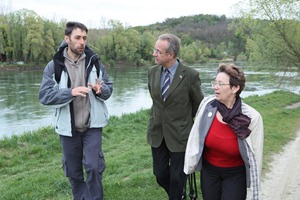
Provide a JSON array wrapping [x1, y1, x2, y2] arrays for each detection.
[[0, 91, 300, 200]]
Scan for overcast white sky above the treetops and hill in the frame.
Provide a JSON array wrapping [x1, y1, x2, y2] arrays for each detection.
[[0, 0, 240, 28]]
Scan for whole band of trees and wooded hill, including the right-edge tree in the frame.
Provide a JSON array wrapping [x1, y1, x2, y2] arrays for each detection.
[[0, 0, 300, 70]]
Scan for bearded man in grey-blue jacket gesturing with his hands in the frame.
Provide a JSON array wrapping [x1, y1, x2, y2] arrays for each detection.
[[39, 22, 113, 200]]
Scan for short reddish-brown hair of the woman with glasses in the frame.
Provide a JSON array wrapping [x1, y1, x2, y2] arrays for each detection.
[[217, 63, 246, 96]]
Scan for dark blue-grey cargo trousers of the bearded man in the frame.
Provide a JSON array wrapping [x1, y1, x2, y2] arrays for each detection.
[[60, 128, 105, 200]]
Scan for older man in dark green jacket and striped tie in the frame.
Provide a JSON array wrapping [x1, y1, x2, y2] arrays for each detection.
[[147, 34, 203, 200]]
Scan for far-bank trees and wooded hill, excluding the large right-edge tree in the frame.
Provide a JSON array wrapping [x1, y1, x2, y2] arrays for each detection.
[[0, 9, 233, 66]]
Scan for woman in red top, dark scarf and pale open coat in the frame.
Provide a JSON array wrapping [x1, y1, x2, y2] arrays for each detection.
[[184, 64, 264, 200]]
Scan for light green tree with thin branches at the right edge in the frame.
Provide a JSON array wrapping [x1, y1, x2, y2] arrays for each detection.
[[237, 0, 300, 70]]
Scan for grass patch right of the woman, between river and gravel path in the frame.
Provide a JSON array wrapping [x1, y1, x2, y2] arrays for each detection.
[[244, 91, 300, 172]]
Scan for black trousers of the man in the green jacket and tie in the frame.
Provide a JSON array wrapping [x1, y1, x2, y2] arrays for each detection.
[[151, 140, 186, 200]]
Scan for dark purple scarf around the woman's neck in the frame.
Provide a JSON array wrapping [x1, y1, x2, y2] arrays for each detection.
[[217, 97, 251, 139]]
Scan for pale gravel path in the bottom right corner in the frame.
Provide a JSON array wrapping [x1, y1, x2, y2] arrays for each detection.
[[261, 130, 300, 200]]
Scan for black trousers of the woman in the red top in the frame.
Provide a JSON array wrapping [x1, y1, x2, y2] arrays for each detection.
[[201, 161, 247, 200]]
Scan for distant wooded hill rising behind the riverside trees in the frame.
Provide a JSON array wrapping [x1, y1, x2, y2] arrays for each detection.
[[134, 14, 234, 48]]
